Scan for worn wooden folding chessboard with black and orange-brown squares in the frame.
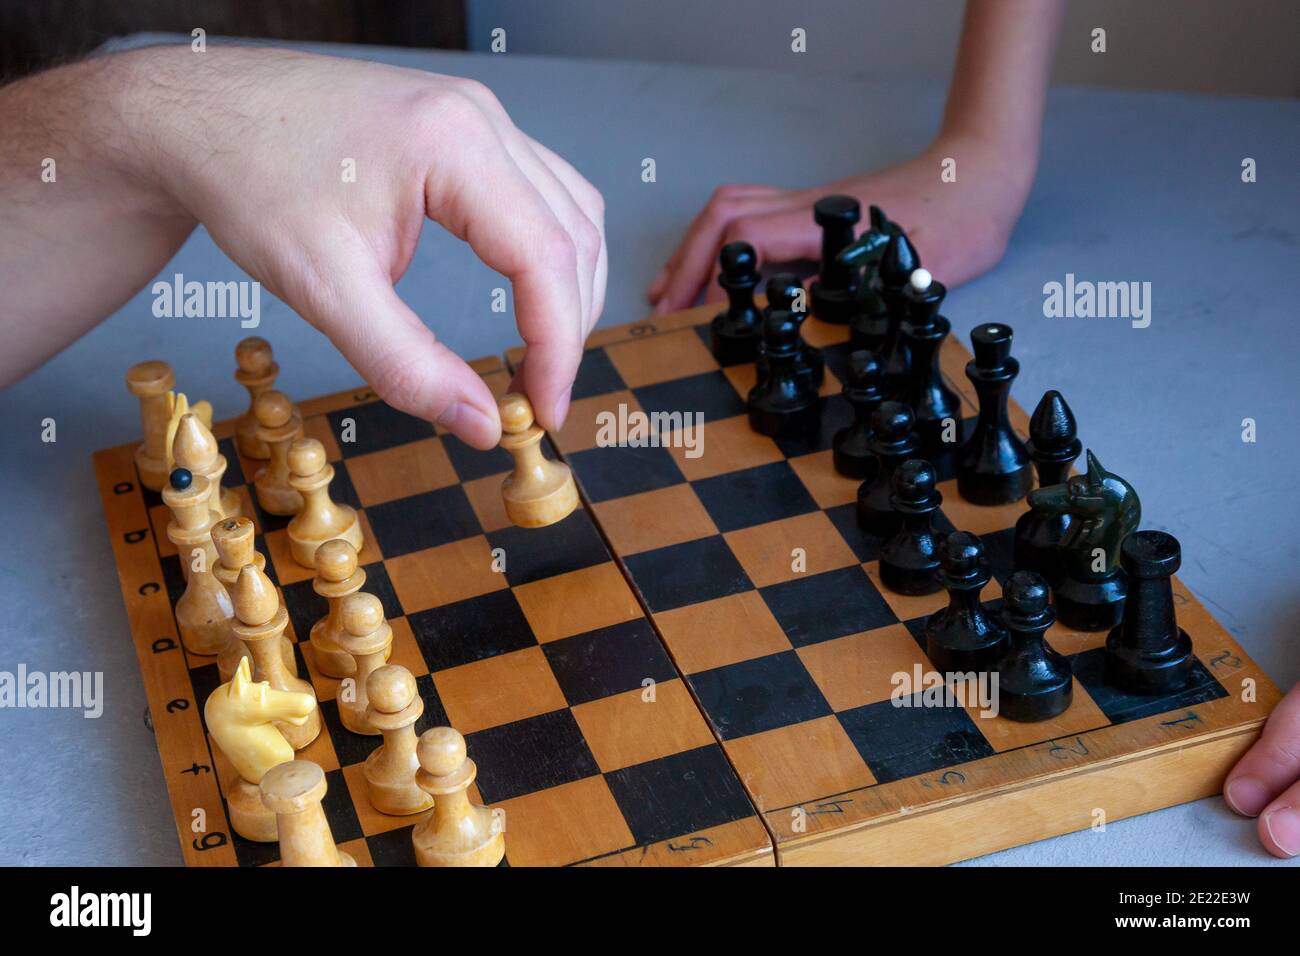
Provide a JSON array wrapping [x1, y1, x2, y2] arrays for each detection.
[[95, 308, 1279, 865]]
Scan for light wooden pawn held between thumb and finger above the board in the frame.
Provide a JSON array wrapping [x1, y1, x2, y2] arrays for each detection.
[[498, 393, 577, 528]]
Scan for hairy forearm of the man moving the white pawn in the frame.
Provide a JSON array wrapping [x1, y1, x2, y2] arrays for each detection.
[[0, 51, 195, 385]]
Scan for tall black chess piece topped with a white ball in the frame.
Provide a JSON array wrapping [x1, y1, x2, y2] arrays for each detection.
[[887, 269, 962, 458]]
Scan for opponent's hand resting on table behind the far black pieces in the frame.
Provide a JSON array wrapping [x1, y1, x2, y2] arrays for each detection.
[[647, 138, 1034, 312]]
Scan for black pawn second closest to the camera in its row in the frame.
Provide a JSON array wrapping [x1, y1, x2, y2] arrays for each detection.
[[922, 531, 1008, 674]]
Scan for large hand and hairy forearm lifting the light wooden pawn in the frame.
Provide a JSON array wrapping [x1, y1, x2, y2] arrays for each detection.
[[0, 46, 606, 447]]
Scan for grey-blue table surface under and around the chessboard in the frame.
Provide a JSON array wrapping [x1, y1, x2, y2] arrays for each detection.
[[0, 38, 1300, 866]]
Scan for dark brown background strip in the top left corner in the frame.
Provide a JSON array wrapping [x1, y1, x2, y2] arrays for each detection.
[[0, 0, 465, 81]]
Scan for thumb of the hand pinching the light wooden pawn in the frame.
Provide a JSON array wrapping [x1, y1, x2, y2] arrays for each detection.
[[308, 265, 501, 450]]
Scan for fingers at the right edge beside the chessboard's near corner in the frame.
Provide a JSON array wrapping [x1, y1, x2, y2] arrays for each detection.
[[1223, 684, 1300, 857]]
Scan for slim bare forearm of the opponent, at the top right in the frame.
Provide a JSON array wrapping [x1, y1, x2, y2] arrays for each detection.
[[943, 0, 1065, 179]]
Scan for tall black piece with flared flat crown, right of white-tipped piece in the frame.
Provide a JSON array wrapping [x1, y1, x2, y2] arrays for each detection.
[[957, 323, 1034, 505]]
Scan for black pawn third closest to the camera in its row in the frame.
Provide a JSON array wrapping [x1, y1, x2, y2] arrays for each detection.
[[880, 458, 944, 594]]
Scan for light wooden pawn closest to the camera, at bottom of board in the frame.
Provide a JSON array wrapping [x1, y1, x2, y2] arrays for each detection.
[[411, 727, 506, 866]]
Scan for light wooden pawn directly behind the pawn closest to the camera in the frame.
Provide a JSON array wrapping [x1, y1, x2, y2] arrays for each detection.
[[364, 663, 433, 817]]
